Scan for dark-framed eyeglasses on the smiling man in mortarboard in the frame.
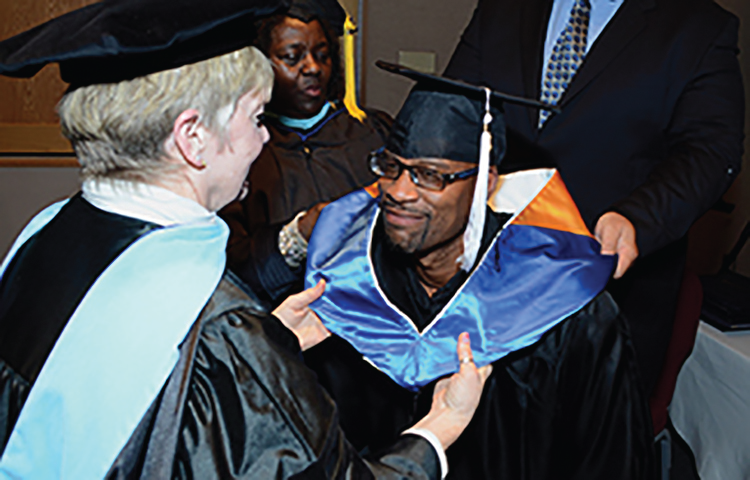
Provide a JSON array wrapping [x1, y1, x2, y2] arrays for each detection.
[[368, 148, 479, 191]]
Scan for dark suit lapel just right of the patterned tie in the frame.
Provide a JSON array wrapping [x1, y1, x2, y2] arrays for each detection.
[[560, 0, 655, 107]]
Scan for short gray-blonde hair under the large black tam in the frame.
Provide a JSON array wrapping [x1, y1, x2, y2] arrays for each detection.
[[57, 47, 273, 183]]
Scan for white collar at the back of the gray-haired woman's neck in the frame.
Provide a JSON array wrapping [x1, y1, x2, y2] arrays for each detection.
[[82, 179, 216, 226]]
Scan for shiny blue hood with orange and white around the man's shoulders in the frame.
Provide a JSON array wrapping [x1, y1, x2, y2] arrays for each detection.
[[306, 170, 615, 390]]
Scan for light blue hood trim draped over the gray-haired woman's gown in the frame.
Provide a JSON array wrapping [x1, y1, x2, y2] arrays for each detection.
[[0, 198, 229, 480]]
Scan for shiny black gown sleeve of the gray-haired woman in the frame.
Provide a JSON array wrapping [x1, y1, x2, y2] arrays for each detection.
[[174, 311, 440, 479]]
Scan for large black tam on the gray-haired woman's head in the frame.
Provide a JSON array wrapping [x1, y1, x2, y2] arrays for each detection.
[[0, 0, 289, 87]]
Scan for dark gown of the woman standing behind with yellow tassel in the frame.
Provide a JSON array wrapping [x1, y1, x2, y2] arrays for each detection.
[[220, 105, 392, 304]]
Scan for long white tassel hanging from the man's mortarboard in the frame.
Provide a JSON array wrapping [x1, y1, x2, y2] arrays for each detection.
[[458, 88, 492, 272]]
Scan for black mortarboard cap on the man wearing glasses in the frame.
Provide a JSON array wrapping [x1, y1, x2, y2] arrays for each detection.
[[376, 61, 560, 165]]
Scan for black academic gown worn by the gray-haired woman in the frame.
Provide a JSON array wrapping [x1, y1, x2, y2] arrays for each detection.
[[0, 195, 440, 479]]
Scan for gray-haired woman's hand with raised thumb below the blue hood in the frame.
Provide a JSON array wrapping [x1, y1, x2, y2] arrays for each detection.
[[413, 332, 492, 449]]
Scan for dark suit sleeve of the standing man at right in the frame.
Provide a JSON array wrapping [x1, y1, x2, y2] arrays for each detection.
[[611, 17, 745, 256]]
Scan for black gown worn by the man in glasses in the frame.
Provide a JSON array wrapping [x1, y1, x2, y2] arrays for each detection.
[[305, 214, 654, 480]]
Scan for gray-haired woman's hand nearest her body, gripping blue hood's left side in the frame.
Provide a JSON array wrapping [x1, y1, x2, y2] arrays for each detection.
[[273, 280, 331, 351]]
